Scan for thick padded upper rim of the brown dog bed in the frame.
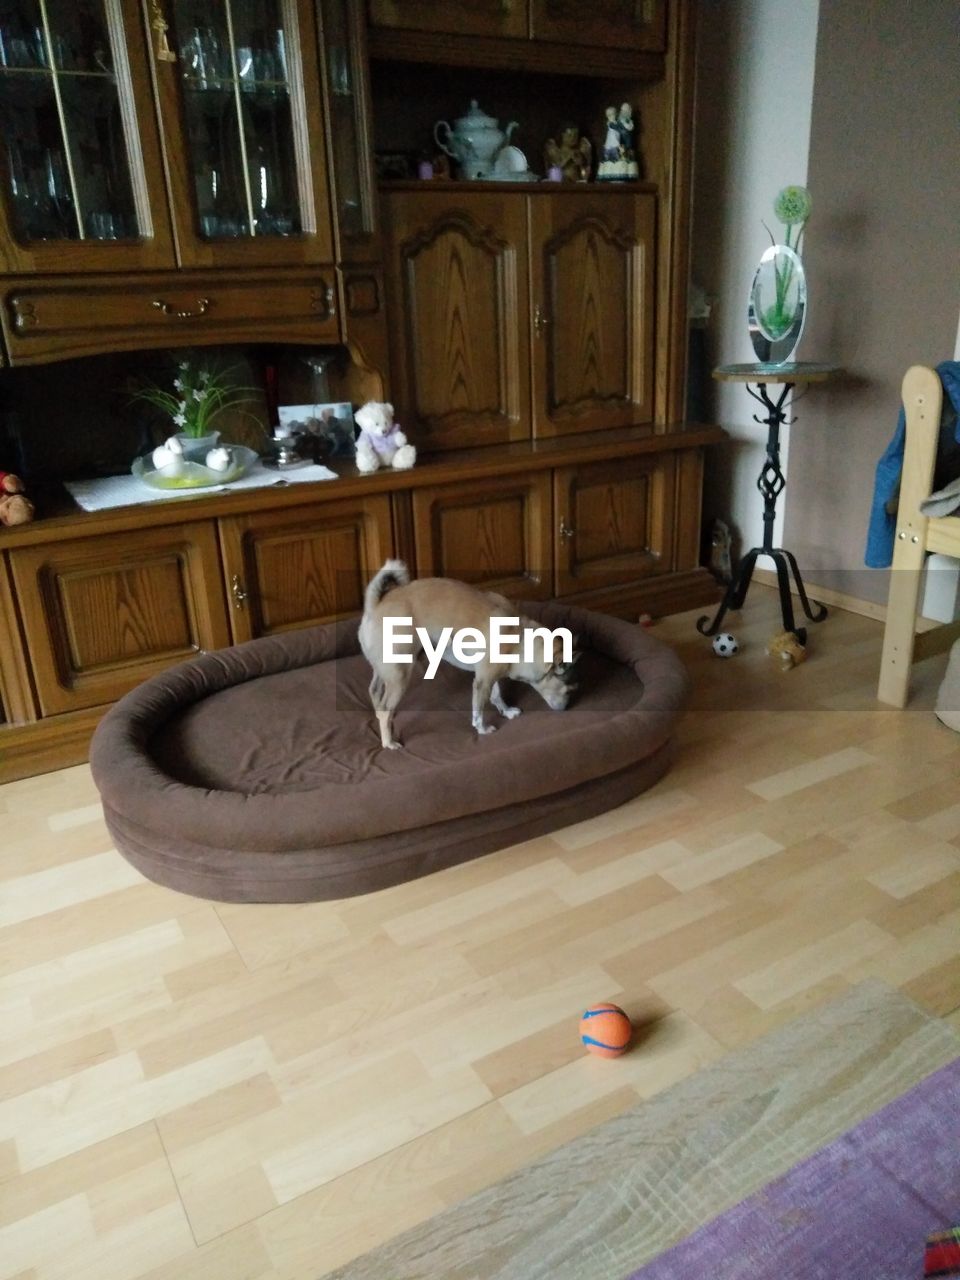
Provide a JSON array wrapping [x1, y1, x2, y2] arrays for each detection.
[[90, 602, 687, 854]]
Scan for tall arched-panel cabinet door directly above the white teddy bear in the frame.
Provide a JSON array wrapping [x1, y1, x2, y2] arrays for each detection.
[[384, 191, 530, 449]]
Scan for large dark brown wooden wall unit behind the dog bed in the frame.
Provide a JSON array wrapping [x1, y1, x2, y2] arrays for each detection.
[[0, 0, 722, 781]]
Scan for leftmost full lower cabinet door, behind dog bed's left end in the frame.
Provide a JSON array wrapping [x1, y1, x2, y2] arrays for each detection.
[[9, 521, 229, 716]]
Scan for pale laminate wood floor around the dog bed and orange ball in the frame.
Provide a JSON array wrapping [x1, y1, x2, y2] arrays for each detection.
[[0, 585, 960, 1280]]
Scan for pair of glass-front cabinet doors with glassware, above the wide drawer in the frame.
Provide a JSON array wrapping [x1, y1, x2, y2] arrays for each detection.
[[0, 0, 333, 274]]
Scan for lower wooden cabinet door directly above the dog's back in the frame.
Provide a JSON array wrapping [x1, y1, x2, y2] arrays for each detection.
[[413, 472, 553, 600]]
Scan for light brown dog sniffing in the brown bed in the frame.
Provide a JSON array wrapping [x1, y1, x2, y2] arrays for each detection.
[[360, 561, 580, 750]]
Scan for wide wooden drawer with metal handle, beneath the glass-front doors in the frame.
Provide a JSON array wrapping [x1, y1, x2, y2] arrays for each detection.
[[3, 268, 339, 364]]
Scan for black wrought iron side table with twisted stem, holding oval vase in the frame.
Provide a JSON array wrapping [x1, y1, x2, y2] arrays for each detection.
[[696, 362, 840, 644]]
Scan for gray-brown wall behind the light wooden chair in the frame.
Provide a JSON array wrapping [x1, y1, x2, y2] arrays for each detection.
[[783, 0, 960, 603]]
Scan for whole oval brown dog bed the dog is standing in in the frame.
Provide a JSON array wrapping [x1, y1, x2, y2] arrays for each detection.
[[90, 603, 686, 902]]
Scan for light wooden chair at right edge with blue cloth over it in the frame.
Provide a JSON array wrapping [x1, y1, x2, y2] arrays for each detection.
[[877, 365, 960, 707]]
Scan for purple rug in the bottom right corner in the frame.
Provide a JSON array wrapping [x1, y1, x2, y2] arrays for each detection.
[[628, 1059, 960, 1280]]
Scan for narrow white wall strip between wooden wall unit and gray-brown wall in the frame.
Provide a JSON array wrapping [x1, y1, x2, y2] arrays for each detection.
[[692, 0, 819, 555]]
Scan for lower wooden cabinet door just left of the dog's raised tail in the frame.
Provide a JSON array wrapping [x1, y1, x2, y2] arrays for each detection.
[[220, 495, 393, 641]]
